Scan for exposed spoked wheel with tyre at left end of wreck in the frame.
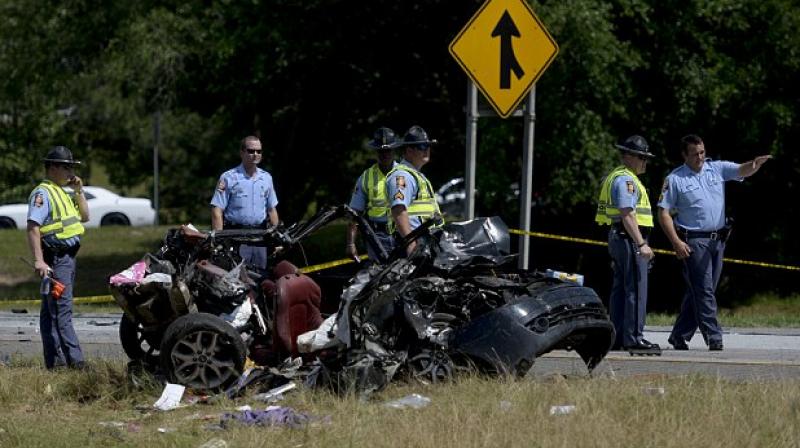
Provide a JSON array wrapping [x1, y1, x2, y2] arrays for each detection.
[[161, 313, 242, 391]]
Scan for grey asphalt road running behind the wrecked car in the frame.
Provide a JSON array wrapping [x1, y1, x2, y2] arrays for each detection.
[[0, 312, 800, 380]]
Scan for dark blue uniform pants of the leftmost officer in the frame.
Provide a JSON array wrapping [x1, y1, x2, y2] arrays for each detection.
[[39, 250, 84, 369]]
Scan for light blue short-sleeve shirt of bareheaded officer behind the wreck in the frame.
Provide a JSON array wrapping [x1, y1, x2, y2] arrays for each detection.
[[211, 165, 278, 226]]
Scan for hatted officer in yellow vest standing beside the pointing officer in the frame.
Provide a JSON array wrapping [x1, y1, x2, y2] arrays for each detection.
[[595, 135, 661, 354]]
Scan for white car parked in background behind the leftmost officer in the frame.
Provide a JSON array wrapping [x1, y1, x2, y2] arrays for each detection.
[[0, 187, 156, 229]]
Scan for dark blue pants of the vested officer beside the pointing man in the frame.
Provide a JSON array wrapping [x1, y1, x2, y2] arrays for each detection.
[[608, 229, 649, 347]]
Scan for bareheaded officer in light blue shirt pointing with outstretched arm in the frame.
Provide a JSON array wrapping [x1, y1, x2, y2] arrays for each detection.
[[658, 134, 772, 351]]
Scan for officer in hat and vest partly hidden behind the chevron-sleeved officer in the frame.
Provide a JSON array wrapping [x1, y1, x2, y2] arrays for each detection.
[[345, 128, 400, 261]]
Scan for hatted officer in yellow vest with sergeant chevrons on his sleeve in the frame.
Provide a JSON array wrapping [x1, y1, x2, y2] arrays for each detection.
[[386, 126, 441, 254]]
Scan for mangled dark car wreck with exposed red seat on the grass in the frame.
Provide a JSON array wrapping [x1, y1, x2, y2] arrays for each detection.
[[110, 206, 614, 391]]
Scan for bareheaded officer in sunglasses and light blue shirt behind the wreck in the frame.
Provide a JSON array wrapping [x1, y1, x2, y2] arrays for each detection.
[[211, 136, 279, 270]]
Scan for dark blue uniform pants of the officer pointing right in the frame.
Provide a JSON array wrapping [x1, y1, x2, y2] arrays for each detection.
[[672, 238, 725, 344]]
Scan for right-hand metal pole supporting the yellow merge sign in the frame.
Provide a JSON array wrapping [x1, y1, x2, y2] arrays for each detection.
[[518, 85, 536, 269]]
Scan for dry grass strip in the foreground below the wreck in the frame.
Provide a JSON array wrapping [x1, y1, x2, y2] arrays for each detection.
[[0, 361, 800, 448]]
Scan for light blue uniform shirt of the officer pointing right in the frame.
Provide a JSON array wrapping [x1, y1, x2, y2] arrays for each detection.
[[658, 159, 742, 232]]
